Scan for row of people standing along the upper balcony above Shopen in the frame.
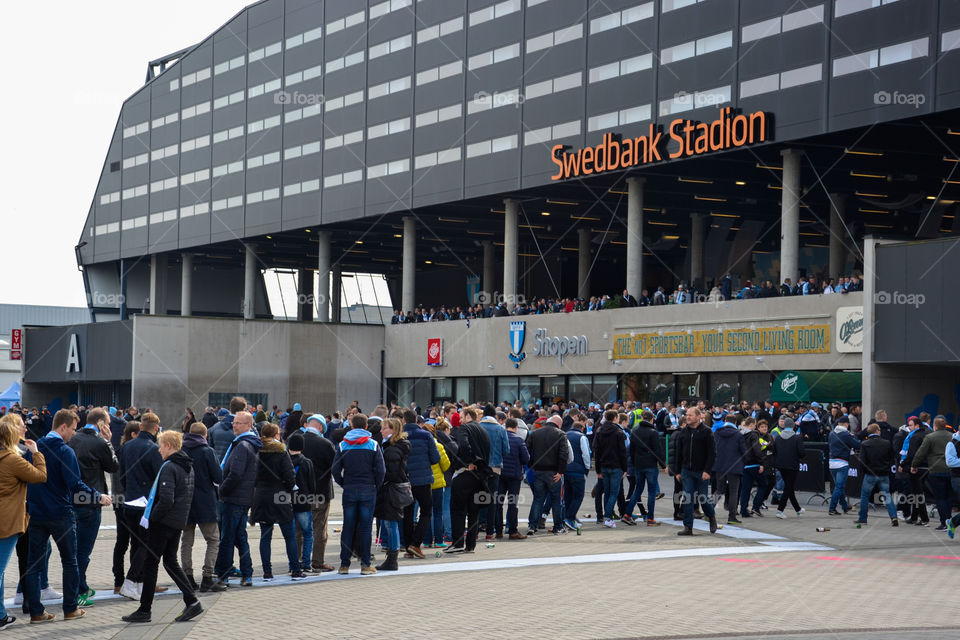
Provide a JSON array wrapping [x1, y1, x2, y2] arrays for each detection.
[[390, 274, 863, 324]]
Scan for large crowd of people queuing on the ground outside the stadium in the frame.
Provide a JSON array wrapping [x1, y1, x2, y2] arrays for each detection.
[[0, 396, 960, 628]]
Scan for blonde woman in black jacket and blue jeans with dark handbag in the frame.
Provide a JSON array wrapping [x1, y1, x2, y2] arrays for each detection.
[[373, 418, 408, 571]]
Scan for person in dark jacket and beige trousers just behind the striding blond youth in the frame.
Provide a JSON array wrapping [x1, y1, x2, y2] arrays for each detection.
[[180, 422, 223, 593]]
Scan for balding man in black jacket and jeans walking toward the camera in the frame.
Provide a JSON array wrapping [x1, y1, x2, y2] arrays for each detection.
[[674, 407, 717, 536]]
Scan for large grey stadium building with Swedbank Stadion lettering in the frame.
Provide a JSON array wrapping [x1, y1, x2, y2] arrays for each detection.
[[18, 0, 960, 428]]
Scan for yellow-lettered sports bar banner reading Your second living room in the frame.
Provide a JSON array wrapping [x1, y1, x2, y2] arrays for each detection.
[[613, 324, 830, 360]]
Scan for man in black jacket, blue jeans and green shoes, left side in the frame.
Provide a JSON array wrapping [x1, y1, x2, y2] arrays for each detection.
[[67, 408, 122, 607]]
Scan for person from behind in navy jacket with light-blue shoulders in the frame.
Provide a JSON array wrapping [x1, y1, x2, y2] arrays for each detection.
[[332, 413, 386, 575]]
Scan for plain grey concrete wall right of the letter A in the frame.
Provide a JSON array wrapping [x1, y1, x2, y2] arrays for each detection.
[[133, 315, 383, 424]]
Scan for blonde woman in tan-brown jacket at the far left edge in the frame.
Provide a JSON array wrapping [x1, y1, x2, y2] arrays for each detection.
[[0, 415, 47, 629]]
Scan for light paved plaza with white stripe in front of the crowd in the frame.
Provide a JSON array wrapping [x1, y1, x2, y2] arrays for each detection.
[[5, 476, 960, 640]]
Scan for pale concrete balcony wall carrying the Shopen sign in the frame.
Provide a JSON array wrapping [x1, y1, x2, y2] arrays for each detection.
[[385, 293, 863, 378]]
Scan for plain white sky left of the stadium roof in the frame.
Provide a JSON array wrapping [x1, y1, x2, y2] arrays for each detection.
[[0, 0, 252, 306]]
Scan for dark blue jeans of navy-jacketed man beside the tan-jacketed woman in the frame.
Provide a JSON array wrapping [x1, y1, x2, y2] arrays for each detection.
[[23, 509, 80, 617]]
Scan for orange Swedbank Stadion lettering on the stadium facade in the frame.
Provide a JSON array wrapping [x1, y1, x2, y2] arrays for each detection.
[[550, 107, 771, 180]]
